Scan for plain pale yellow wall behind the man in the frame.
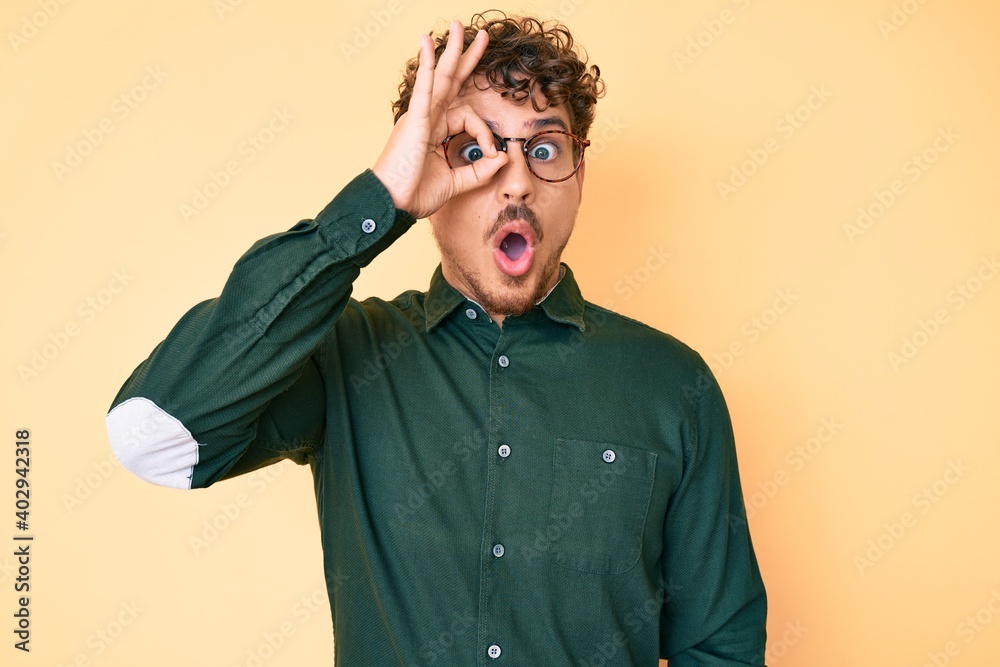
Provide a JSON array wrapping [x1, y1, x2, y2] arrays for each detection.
[[0, 0, 1000, 667]]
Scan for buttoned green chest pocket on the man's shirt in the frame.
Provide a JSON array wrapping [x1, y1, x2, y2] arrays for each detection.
[[549, 438, 656, 574]]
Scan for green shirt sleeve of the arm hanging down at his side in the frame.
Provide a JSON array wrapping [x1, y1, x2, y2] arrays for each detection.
[[660, 367, 767, 667]]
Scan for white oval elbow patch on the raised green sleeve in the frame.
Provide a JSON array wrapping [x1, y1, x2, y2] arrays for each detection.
[[106, 396, 199, 489]]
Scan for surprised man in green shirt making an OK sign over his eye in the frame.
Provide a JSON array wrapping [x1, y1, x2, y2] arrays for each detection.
[[107, 10, 766, 667]]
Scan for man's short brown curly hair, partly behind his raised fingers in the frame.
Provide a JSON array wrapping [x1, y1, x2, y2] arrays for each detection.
[[392, 10, 604, 137]]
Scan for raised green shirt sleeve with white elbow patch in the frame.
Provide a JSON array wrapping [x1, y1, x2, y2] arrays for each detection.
[[106, 170, 415, 489]]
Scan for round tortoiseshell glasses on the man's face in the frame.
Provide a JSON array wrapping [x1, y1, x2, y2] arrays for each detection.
[[441, 130, 590, 183]]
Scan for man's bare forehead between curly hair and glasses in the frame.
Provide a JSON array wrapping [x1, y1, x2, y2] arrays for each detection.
[[450, 78, 572, 134]]
